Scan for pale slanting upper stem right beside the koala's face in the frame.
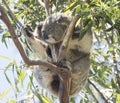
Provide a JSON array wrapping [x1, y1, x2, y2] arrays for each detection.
[[58, 15, 80, 62]]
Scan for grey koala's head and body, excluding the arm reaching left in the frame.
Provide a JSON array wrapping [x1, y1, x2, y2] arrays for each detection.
[[26, 13, 93, 96]]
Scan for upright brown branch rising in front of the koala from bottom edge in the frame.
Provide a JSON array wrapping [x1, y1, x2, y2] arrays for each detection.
[[58, 15, 79, 103]]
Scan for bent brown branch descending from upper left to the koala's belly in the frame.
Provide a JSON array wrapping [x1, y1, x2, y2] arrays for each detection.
[[0, 5, 64, 75]]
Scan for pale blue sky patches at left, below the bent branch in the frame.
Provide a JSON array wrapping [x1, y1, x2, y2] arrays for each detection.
[[0, 34, 21, 99]]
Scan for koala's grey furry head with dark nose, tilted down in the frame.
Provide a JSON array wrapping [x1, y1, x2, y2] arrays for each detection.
[[34, 13, 71, 44]]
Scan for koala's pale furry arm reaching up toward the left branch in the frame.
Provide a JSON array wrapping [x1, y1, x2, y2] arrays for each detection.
[[25, 26, 48, 59]]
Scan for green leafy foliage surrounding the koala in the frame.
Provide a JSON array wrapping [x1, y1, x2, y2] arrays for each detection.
[[0, 0, 120, 103]]
